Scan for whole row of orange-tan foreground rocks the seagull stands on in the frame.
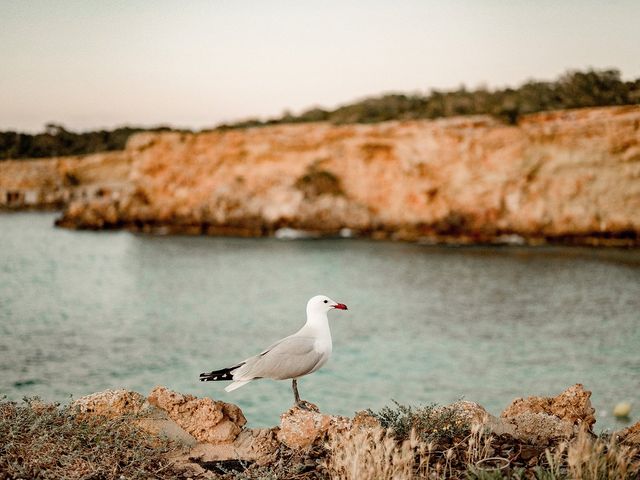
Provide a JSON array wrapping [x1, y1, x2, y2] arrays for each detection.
[[73, 384, 640, 478]]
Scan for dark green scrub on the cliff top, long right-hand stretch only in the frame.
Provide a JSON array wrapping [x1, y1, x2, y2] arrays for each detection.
[[218, 70, 640, 128]]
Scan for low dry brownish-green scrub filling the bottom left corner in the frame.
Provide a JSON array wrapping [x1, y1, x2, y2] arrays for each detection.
[[0, 399, 177, 479]]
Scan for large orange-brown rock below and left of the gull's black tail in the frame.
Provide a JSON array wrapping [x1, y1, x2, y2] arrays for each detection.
[[148, 386, 247, 444]]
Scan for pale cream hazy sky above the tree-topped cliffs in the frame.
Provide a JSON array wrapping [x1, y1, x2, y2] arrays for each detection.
[[0, 0, 640, 132]]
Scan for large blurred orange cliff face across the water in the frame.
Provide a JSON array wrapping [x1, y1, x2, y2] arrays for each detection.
[[38, 106, 640, 244]]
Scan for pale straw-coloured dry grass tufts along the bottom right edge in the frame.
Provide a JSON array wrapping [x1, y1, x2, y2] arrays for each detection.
[[326, 426, 640, 480]]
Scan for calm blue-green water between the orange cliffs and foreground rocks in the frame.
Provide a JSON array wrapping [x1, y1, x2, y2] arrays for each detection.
[[0, 213, 640, 429]]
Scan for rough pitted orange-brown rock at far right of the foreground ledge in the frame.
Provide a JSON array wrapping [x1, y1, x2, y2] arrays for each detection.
[[500, 384, 596, 445]]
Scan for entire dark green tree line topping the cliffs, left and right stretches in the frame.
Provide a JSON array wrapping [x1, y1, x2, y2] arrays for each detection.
[[0, 69, 640, 160]]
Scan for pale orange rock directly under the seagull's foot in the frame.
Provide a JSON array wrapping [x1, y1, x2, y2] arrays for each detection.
[[277, 403, 352, 450]]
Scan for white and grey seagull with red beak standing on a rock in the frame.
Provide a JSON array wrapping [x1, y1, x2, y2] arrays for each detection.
[[200, 295, 347, 407]]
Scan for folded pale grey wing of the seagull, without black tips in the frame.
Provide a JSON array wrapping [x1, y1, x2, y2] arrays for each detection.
[[233, 335, 325, 380]]
